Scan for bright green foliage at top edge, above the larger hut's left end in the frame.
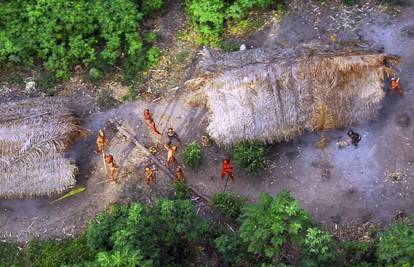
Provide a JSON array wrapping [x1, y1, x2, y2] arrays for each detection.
[[185, 0, 280, 46]]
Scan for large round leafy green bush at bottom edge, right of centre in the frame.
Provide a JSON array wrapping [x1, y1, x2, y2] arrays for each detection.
[[239, 191, 312, 263]]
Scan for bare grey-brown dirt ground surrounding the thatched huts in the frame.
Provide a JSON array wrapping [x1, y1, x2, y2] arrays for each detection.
[[0, 1, 414, 242]]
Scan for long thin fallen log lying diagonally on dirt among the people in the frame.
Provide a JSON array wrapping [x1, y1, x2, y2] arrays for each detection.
[[109, 119, 211, 204]]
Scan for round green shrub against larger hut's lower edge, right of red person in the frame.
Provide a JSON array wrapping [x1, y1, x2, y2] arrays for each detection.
[[233, 141, 266, 173]]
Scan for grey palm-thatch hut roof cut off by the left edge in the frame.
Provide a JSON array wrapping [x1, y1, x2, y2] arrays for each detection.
[[0, 97, 86, 198]]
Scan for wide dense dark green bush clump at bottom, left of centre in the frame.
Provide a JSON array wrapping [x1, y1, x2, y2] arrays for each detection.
[[86, 199, 211, 266]]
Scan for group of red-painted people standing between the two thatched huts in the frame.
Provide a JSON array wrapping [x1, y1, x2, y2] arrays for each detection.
[[96, 109, 235, 187]]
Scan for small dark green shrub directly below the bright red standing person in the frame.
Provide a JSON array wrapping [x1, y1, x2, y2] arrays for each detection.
[[212, 193, 247, 219]]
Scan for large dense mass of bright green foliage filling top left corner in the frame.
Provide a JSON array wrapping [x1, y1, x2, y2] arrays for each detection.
[[0, 0, 164, 83]]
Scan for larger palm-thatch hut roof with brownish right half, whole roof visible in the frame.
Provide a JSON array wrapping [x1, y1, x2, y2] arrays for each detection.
[[187, 43, 399, 145]]
